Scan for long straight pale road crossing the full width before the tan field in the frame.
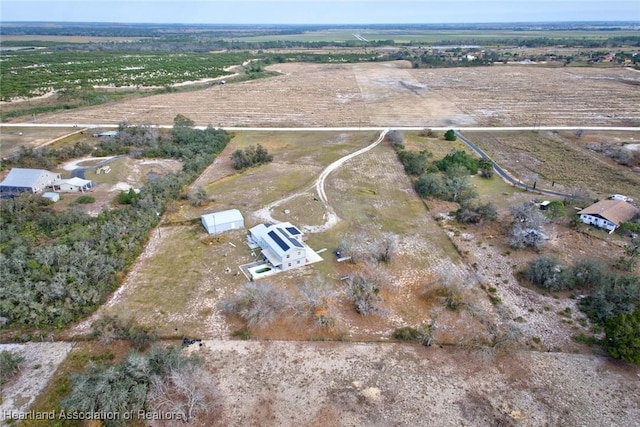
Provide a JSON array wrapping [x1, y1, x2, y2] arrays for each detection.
[[0, 122, 640, 132]]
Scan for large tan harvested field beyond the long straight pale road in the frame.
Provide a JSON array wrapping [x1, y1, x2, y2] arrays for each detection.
[[27, 61, 640, 127]]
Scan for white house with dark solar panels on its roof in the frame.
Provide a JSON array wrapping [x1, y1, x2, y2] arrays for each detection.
[[250, 222, 322, 271]]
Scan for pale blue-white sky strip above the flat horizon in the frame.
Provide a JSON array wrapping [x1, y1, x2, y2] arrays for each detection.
[[0, 0, 640, 24]]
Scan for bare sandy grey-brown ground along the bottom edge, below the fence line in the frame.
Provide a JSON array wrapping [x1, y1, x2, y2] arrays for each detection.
[[194, 341, 640, 426]]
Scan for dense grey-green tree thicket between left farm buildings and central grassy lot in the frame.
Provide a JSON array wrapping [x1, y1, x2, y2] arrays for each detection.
[[0, 114, 229, 330]]
